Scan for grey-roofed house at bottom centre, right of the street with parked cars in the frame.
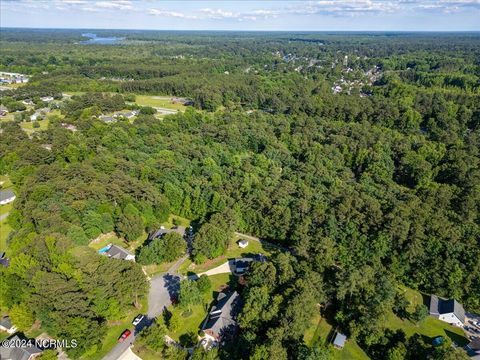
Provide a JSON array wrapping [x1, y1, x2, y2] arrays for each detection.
[[203, 291, 240, 342]]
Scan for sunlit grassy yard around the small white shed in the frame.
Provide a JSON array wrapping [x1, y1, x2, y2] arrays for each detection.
[[178, 238, 278, 274]]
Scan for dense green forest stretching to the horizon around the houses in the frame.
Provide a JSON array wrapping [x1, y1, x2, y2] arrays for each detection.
[[0, 29, 480, 359]]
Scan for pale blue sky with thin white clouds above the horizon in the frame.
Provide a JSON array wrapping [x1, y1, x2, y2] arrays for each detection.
[[0, 0, 480, 31]]
